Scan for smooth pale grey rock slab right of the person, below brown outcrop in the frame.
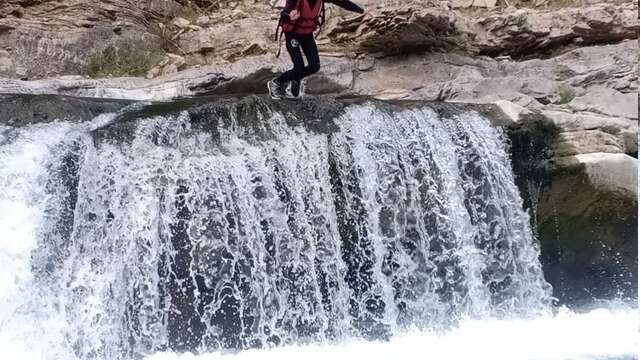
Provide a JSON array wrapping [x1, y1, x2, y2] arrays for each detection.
[[354, 41, 637, 108]]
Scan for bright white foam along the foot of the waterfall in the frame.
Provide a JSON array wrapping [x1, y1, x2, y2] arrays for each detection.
[[146, 309, 638, 360]]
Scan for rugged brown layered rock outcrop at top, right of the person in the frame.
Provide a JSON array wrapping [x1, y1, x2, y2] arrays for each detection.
[[328, 2, 640, 57]]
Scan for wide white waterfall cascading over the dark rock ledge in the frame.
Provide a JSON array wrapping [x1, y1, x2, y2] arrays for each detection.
[[0, 98, 551, 359]]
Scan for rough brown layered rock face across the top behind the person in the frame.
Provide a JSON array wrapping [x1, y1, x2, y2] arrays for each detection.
[[0, 0, 640, 80]]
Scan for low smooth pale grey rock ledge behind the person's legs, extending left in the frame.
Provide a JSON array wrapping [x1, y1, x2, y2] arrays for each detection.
[[0, 55, 353, 101]]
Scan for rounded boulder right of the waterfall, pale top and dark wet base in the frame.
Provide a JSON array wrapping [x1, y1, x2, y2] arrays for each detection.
[[536, 153, 638, 306]]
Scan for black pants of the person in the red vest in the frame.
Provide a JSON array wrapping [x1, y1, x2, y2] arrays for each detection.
[[276, 33, 320, 84]]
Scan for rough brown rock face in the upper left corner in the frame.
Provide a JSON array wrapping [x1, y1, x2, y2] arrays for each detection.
[[0, 0, 177, 79]]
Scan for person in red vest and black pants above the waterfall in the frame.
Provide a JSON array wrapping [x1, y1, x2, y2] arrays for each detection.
[[267, 0, 364, 99]]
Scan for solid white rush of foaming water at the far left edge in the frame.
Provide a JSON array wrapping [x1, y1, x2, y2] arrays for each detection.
[[0, 123, 78, 359]]
